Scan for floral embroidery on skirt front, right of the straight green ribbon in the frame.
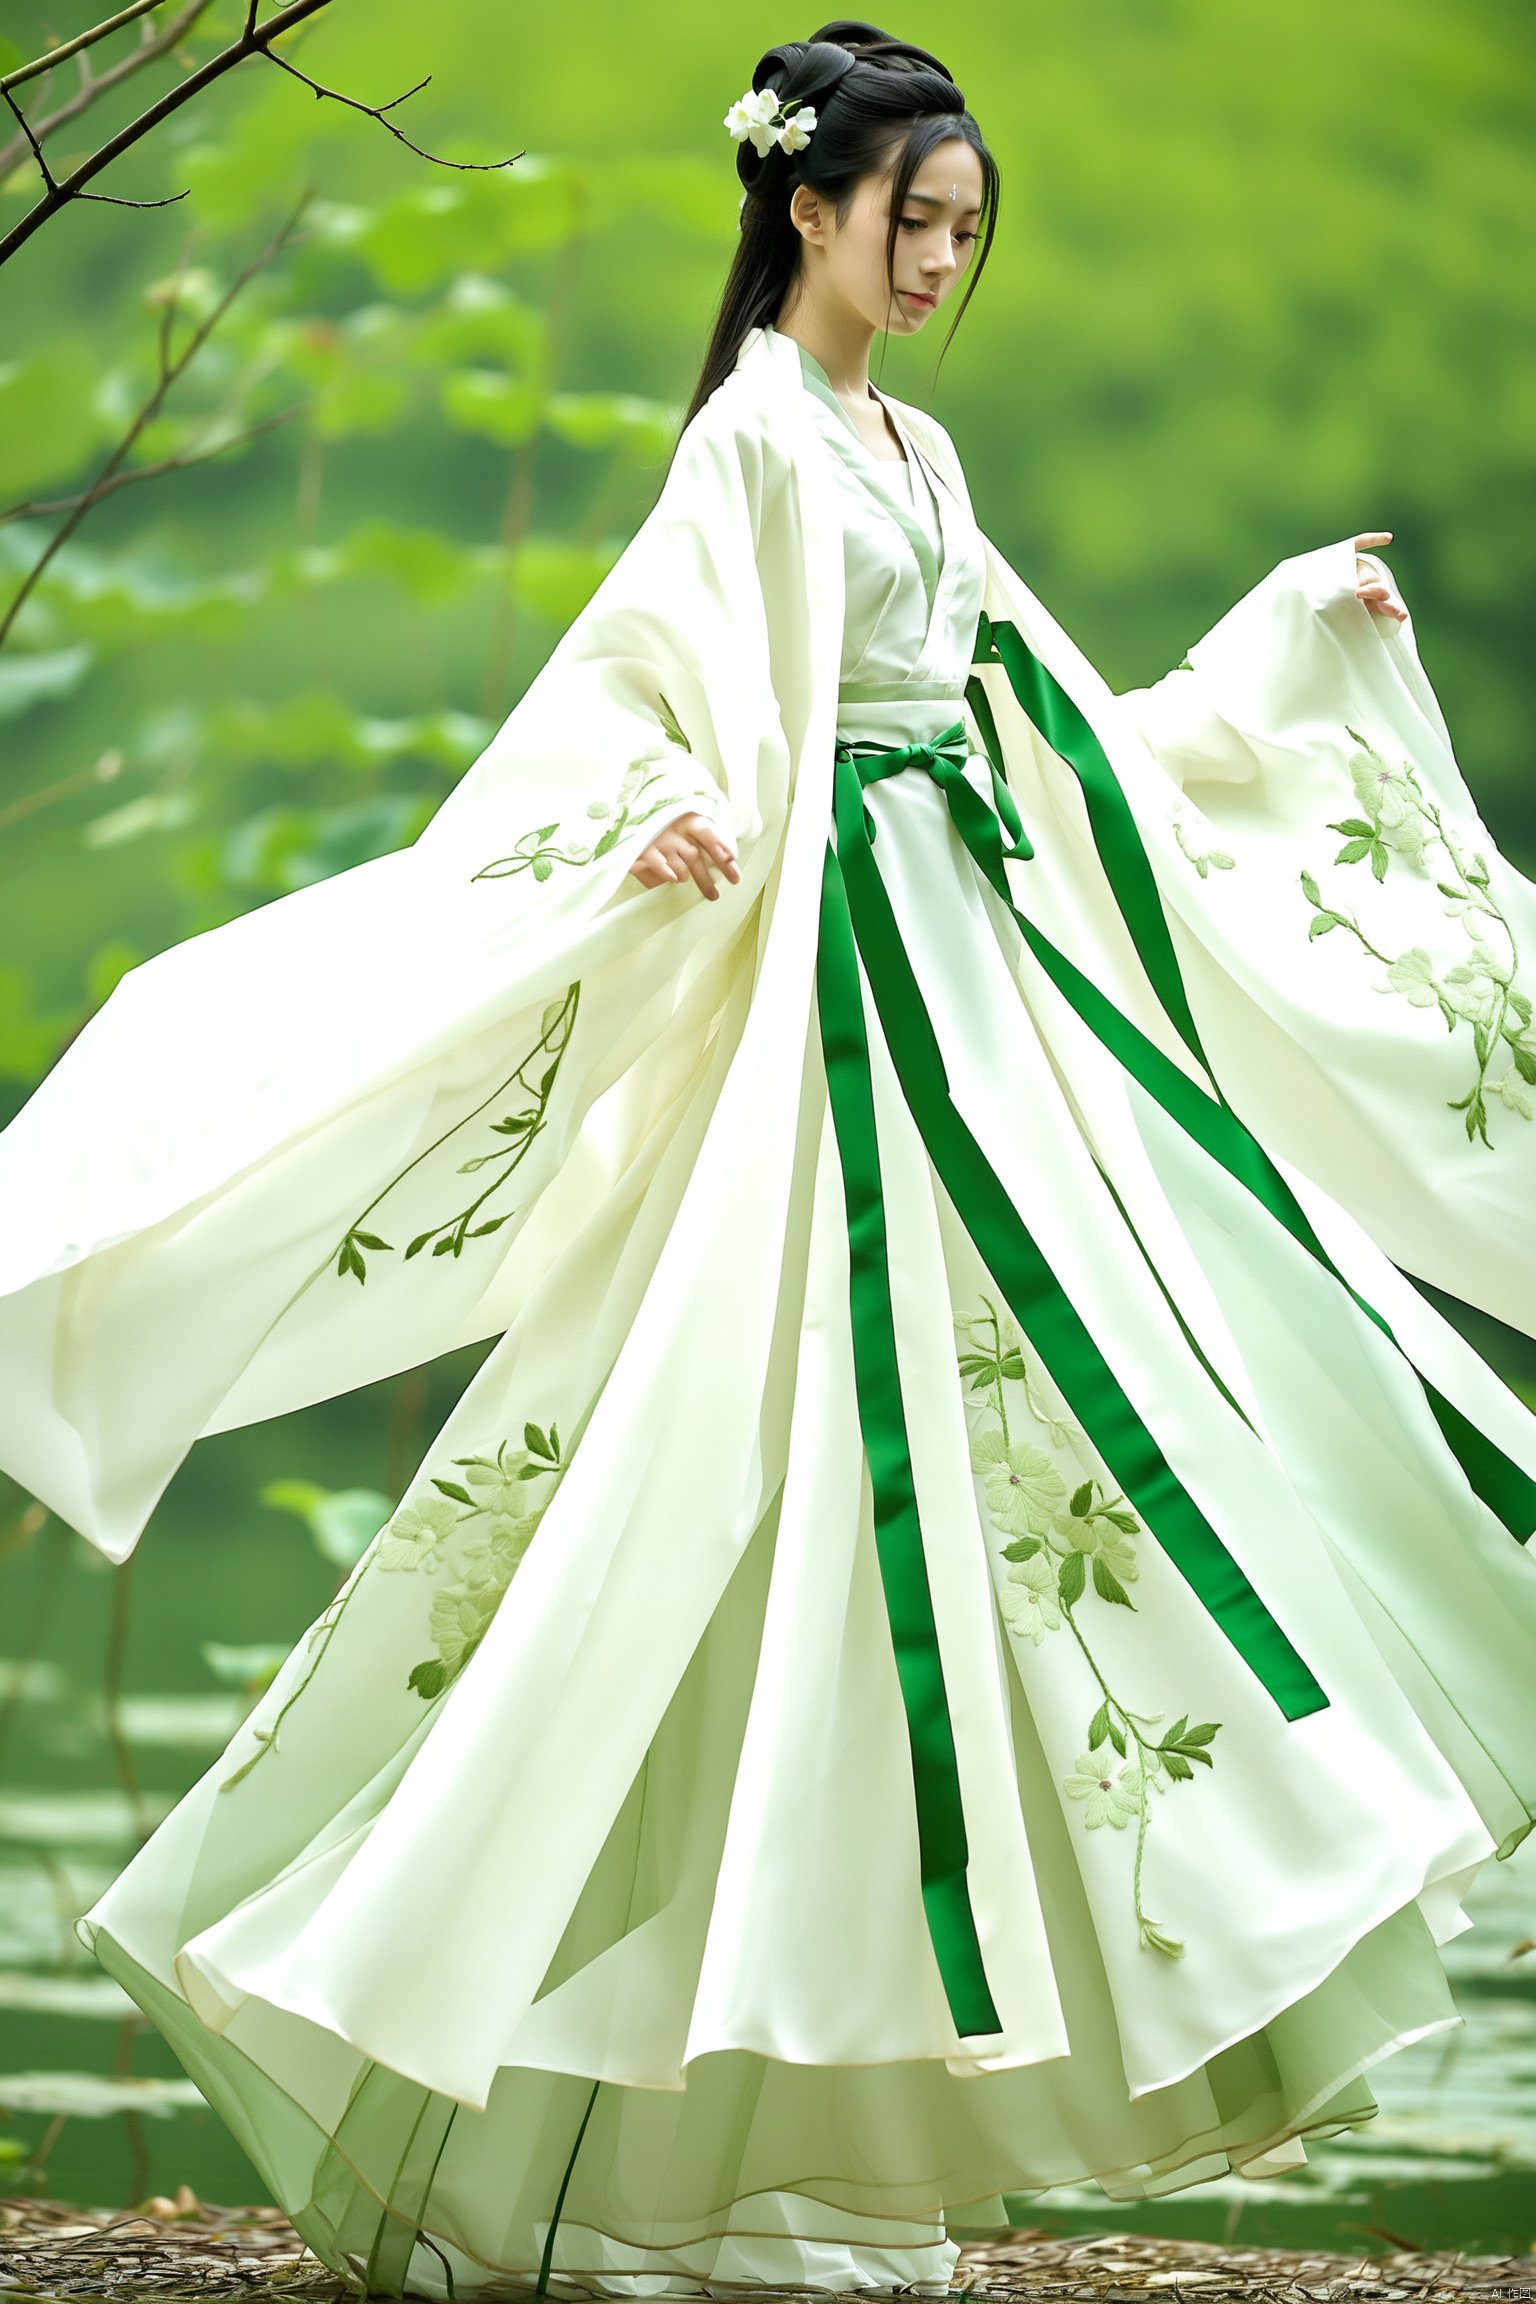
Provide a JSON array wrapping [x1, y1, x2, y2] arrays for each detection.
[[956, 1295, 1221, 1958]]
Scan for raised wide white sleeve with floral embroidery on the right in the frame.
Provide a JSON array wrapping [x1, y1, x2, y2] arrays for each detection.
[[1105, 539, 1536, 1332]]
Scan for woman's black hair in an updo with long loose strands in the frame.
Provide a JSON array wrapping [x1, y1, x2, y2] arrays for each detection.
[[684, 18, 999, 426]]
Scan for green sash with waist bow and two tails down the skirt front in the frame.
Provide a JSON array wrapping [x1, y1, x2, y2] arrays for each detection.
[[815, 721, 1326, 2037]]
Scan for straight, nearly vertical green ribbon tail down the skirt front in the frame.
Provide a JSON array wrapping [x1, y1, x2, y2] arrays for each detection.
[[815, 843, 1002, 2039]]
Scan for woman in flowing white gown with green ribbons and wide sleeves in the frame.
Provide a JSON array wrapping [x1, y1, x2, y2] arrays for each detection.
[[0, 23, 1536, 2297]]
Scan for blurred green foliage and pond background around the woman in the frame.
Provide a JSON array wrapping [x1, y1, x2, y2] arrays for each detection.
[[0, 0, 1536, 2249]]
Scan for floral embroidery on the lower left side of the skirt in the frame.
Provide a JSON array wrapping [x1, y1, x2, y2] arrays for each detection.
[[219, 1424, 564, 1793]]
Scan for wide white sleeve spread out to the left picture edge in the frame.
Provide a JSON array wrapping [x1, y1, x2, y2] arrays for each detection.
[[0, 394, 792, 1558]]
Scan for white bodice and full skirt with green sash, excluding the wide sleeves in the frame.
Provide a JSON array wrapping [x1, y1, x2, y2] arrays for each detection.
[[8, 332, 1536, 2297]]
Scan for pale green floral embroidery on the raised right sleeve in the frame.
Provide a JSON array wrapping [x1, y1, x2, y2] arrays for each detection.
[[1301, 728, 1536, 1147]]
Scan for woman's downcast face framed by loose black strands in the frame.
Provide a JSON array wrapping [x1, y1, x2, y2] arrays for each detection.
[[790, 136, 983, 336]]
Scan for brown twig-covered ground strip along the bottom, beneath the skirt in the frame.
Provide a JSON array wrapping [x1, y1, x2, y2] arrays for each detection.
[[0, 2191, 1536, 2304]]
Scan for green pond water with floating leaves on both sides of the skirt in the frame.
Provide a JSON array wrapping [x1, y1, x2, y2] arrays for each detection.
[[0, 1350, 1536, 2256]]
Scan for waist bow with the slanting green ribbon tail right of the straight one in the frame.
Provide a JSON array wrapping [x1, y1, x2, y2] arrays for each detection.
[[822, 730, 1326, 1719]]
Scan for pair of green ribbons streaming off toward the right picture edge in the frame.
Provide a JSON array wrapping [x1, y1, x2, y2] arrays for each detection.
[[962, 615, 1536, 1544]]
